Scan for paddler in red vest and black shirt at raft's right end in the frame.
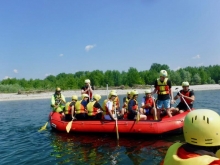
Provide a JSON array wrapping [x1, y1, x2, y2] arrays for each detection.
[[171, 81, 195, 113]]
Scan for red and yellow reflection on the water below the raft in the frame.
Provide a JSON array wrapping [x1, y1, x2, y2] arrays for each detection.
[[51, 132, 173, 164]]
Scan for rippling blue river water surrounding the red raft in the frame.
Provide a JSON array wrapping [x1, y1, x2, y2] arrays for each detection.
[[0, 90, 220, 165]]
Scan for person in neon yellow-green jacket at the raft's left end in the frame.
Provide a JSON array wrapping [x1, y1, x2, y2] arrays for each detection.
[[51, 87, 66, 116]]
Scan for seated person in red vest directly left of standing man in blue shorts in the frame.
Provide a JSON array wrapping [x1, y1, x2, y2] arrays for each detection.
[[140, 89, 160, 120]]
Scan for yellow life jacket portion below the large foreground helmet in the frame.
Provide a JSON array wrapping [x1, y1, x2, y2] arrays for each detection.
[[164, 143, 219, 165]]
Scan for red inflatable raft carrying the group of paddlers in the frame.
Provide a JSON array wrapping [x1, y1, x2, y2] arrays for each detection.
[[49, 111, 189, 134]]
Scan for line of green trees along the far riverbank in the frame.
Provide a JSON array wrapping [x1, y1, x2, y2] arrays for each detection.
[[0, 63, 220, 93]]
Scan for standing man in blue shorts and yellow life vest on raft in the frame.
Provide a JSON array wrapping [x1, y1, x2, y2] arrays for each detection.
[[151, 70, 174, 117]]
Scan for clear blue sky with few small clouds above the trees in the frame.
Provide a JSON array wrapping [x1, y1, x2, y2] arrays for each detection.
[[0, 0, 220, 80]]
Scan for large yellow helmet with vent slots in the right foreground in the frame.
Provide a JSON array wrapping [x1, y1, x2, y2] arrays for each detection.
[[183, 109, 220, 146]]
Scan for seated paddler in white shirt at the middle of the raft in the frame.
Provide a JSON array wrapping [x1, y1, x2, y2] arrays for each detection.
[[102, 91, 123, 120]]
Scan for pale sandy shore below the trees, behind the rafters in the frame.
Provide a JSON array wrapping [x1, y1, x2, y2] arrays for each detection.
[[0, 84, 220, 101]]
